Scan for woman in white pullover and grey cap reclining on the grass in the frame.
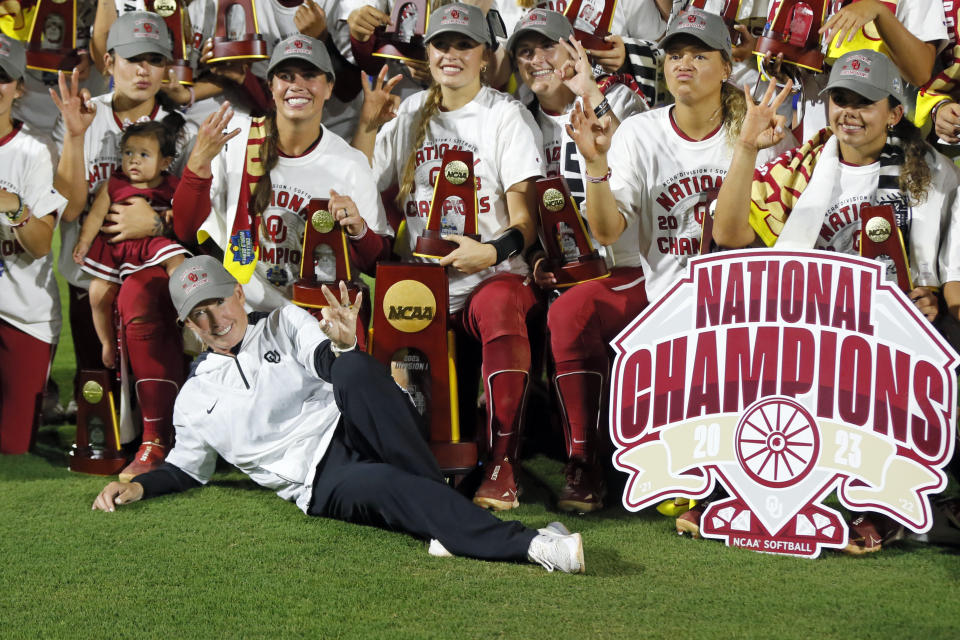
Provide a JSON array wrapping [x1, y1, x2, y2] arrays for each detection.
[[93, 256, 584, 573]]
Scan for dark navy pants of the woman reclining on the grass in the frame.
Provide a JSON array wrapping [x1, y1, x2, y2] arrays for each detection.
[[308, 351, 536, 560]]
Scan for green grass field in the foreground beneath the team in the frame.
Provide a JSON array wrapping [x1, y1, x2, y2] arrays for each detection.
[[0, 241, 960, 640]]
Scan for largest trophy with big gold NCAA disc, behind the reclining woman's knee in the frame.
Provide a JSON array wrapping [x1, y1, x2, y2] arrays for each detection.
[[370, 263, 477, 475]]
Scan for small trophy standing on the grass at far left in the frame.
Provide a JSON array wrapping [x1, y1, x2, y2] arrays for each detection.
[[68, 369, 127, 476]]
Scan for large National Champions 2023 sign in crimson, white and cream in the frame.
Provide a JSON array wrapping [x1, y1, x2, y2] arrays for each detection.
[[610, 250, 960, 557]]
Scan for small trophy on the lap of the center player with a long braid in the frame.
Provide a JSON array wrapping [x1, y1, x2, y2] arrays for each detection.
[[413, 149, 480, 258]]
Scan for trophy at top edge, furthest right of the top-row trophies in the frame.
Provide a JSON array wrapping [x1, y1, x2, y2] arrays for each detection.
[[754, 0, 827, 71]]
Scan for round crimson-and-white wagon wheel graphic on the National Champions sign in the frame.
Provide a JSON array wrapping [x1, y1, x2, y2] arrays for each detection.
[[734, 398, 820, 488]]
